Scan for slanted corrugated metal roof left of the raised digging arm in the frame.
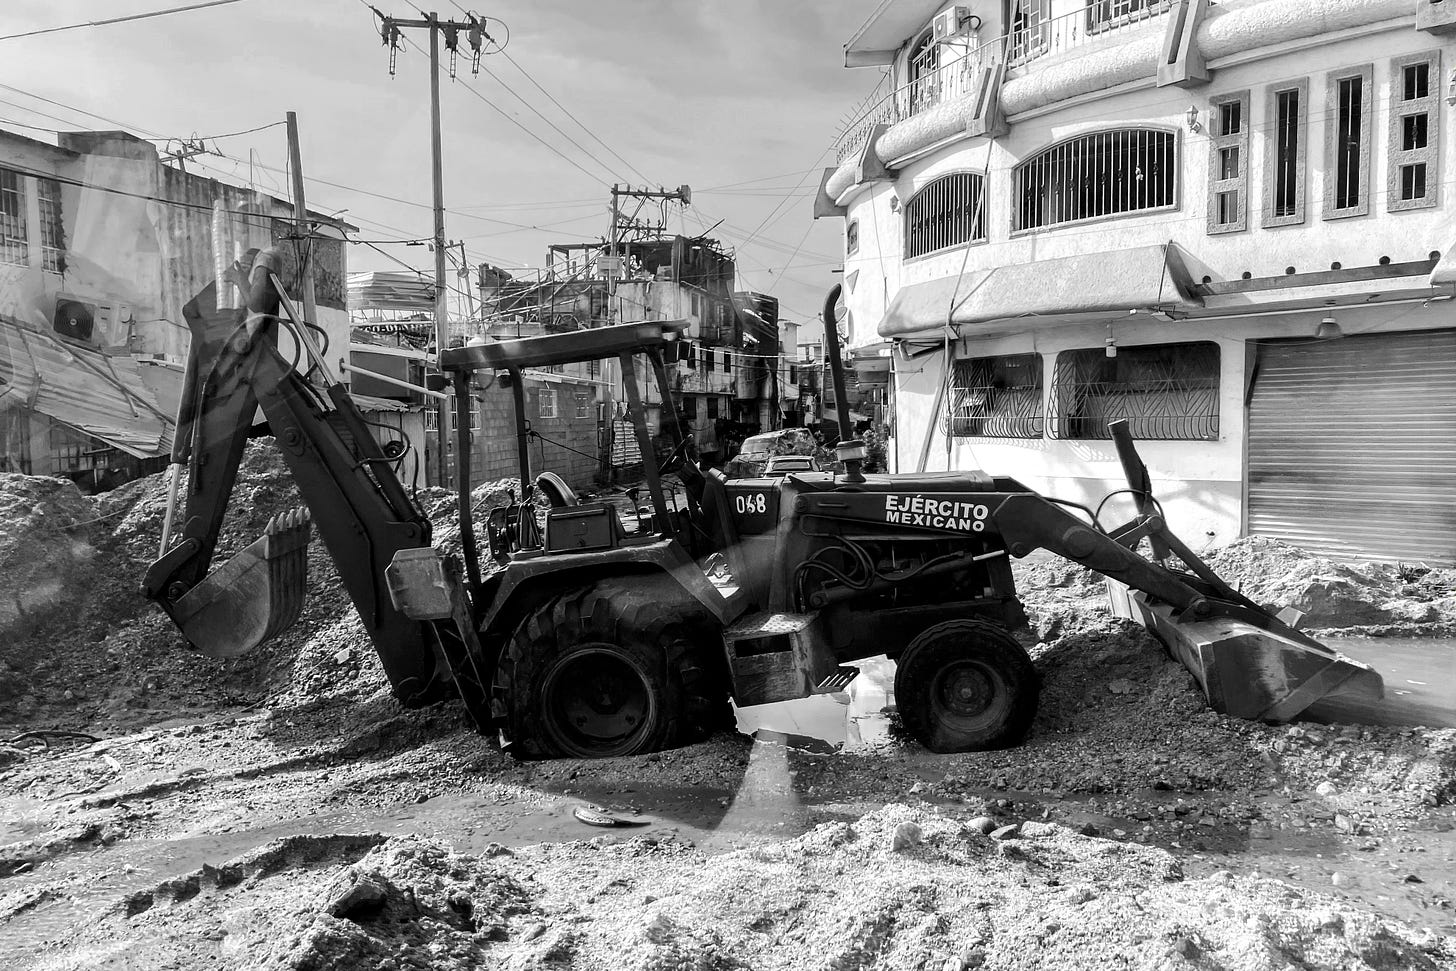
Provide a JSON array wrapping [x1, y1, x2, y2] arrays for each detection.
[[0, 316, 173, 459]]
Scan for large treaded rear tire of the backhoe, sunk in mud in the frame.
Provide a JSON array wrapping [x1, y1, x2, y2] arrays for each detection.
[[496, 575, 731, 758]]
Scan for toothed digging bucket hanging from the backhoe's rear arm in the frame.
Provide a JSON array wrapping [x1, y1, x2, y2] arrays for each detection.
[[172, 510, 310, 658]]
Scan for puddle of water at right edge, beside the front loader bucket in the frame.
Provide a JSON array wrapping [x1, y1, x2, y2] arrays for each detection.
[[1305, 638, 1456, 728]]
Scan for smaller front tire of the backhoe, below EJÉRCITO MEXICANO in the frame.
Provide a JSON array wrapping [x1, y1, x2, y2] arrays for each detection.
[[895, 620, 1040, 753]]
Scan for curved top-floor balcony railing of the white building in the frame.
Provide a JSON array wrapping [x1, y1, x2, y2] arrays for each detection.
[[836, 0, 1172, 163]]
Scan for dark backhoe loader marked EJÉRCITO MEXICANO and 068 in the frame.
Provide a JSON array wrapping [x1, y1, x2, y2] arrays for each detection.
[[143, 250, 1382, 757]]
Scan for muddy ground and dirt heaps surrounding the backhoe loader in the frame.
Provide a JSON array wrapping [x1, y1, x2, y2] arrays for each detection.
[[0, 445, 1456, 971]]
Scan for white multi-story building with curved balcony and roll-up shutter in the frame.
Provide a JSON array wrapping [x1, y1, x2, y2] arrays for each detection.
[[815, 0, 1456, 563]]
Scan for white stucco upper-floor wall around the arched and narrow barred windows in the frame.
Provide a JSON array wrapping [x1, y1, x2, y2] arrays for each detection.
[[844, 28, 1456, 353]]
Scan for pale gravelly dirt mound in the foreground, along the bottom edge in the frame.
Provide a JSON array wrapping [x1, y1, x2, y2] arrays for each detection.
[[52, 805, 1456, 971]]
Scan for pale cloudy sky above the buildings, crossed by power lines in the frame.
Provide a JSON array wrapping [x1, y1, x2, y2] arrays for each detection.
[[0, 0, 878, 331]]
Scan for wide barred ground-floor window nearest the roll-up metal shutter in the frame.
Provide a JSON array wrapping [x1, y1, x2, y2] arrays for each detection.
[[1050, 341, 1219, 441]]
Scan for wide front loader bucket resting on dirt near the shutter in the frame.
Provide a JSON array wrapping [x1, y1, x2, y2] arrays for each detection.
[[1108, 582, 1385, 722]]
